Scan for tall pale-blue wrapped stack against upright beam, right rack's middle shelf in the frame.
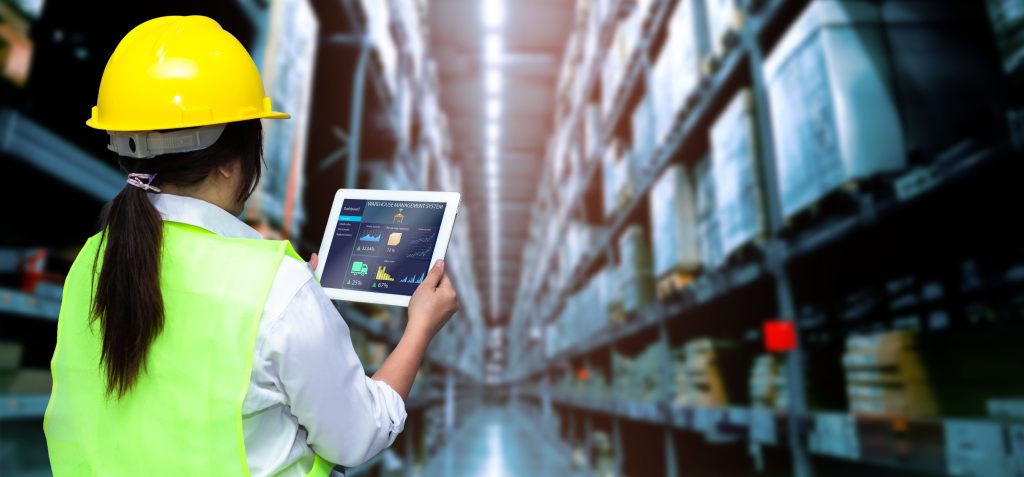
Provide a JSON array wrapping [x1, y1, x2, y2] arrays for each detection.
[[711, 89, 765, 261]]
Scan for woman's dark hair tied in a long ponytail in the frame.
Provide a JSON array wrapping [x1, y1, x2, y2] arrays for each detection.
[[91, 120, 263, 398]]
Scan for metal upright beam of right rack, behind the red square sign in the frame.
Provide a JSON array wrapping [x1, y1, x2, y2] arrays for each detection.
[[739, 6, 814, 477]]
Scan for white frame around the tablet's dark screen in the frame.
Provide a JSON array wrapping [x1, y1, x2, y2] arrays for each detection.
[[316, 188, 462, 306]]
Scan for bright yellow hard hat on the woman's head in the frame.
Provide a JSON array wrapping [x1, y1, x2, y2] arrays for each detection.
[[85, 15, 289, 131]]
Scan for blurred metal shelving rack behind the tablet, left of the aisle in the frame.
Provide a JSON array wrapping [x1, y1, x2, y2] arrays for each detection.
[[319, 0, 484, 475]]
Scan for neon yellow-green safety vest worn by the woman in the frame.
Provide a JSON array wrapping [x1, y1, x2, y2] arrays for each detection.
[[43, 222, 334, 477]]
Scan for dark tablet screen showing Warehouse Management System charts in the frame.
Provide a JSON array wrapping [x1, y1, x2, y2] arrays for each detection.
[[321, 199, 445, 296]]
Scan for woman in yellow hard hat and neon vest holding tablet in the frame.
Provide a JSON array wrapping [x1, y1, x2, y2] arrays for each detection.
[[44, 16, 458, 476]]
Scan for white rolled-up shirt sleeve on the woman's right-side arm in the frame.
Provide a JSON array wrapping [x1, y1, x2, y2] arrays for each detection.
[[271, 261, 407, 467]]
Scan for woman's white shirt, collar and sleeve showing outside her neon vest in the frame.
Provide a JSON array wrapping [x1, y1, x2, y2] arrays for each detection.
[[148, 193, 406, 477]]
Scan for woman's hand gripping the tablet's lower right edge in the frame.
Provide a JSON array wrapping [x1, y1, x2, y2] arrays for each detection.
[[406, 260, 459, 339]]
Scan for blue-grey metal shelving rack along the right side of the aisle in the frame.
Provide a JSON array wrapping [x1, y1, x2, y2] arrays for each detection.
[[506, 0, 1024, 477]]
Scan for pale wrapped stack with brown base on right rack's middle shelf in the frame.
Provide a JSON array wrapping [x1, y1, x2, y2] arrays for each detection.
[[648, 164, 701, 298]]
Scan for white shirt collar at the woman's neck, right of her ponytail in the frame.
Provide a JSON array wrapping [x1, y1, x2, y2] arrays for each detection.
[[146, 193, 263, 239]]
